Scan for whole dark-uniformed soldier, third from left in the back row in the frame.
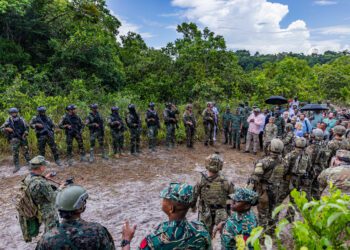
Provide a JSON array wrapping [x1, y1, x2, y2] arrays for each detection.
[[58, 104, 87, 166]]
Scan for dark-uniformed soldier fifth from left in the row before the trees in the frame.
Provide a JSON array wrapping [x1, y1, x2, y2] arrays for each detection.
[[108, 106, 125, 158]]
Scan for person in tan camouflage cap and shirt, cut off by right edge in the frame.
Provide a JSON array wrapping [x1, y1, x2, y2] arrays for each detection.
[[318, 150, 350, 195]]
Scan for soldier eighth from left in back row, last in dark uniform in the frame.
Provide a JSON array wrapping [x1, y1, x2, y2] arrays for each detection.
[[163, 102, 179, 149]]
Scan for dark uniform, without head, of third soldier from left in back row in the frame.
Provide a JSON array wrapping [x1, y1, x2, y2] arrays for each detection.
[[58, 114, 85, 159]]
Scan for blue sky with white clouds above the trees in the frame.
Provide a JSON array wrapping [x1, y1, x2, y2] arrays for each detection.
[[107, 0, 350, 54]]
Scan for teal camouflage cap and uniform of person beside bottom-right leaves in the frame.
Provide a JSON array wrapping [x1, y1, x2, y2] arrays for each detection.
[[221, 188, 258, 250]]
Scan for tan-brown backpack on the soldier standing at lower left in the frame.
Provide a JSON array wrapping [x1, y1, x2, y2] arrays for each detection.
[[15, 179, 38, 219]]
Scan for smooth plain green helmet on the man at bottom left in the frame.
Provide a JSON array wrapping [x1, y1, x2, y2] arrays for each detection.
[[56, 185, 89, 212]]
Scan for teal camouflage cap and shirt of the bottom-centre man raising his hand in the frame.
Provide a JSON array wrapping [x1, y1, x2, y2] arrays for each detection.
[[139, 183, 212, 250]]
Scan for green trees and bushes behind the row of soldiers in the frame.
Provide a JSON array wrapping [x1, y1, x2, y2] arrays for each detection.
[[0, 0, 350, 153]]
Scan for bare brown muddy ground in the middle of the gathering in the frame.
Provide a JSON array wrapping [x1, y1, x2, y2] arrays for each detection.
[[0, 143, 259, 250]]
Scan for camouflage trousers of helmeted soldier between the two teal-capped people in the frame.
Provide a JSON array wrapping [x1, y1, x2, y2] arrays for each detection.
[[199, 206, 228, 235]]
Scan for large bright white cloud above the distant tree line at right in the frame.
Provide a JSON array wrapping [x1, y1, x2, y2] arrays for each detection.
[[172, 0, 346, 53]]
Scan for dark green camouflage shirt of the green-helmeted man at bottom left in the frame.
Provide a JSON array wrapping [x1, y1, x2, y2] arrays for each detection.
[[36, 219, 115, 250]]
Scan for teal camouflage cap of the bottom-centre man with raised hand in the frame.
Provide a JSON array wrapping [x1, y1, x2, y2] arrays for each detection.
[[160, 183, 193, 204]]
